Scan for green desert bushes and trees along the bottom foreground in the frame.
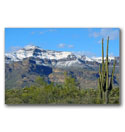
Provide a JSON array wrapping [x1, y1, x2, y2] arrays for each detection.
[[5, 75, 119, 104]]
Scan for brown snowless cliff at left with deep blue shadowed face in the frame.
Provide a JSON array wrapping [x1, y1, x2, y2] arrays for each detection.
[[5, 58, 52, 89]]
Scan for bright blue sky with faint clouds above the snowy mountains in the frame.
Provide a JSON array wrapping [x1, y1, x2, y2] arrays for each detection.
[[5, 28, 119, 57]]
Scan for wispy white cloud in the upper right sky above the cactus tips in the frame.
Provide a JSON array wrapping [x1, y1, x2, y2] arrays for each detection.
[[89, 28, 119, 40]]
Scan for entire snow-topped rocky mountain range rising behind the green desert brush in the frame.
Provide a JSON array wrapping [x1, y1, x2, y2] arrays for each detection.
[[5, 46, 119, 89]]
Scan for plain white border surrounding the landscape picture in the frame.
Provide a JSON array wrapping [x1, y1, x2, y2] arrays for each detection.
[[0, 0, 125, 132]]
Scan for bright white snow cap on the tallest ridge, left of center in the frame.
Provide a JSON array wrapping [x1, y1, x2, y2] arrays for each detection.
[[5, 45, 73, 62]]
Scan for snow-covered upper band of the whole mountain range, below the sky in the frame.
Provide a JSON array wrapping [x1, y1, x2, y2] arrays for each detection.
[[5, 45, 117, 67]]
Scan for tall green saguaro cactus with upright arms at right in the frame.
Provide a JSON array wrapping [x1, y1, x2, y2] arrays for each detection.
[[98, 37, 116, 104]]
